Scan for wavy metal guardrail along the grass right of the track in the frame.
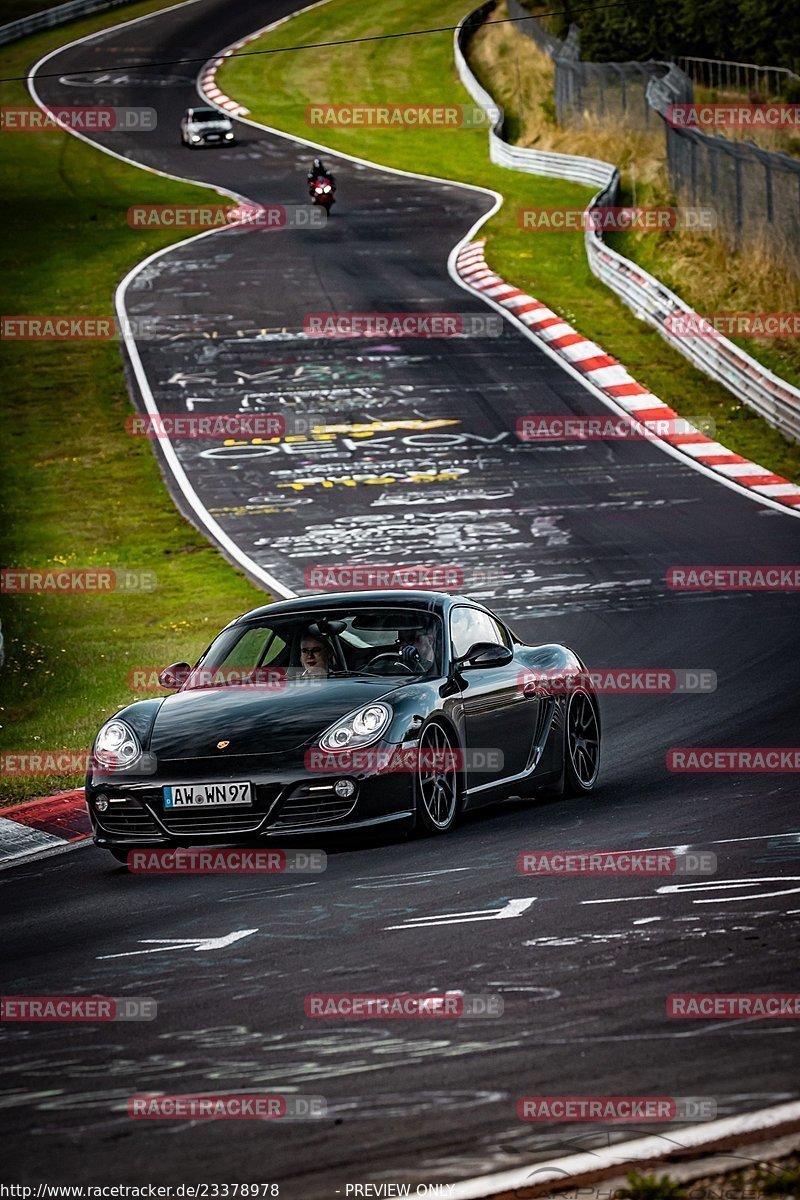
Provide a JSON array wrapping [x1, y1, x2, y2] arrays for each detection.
[[453, 0, 800, 442]]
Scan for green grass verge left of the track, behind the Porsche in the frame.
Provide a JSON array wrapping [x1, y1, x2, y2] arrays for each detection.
[[0, 0, 264, 804]]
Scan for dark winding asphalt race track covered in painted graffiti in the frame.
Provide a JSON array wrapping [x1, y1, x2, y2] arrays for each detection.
[[0, 0, 800, 1200]]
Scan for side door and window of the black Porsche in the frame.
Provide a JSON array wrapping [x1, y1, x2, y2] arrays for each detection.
[[450, 605, 539, 790]]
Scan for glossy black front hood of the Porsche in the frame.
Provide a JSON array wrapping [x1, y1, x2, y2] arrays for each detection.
[[150, 678, 402, 758]]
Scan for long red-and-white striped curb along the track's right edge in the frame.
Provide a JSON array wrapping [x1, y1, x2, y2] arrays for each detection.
[[456, 239, 800, 508]]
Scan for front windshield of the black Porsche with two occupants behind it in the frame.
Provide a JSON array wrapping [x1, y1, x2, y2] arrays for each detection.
[[191, 605, 443, 690]]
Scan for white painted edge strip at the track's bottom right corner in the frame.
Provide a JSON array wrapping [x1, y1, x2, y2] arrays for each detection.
[[449, 1100, 800, 1200]]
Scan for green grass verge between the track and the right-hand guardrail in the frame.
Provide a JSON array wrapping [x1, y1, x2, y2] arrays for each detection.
[[218, 0, 800, 481]]
